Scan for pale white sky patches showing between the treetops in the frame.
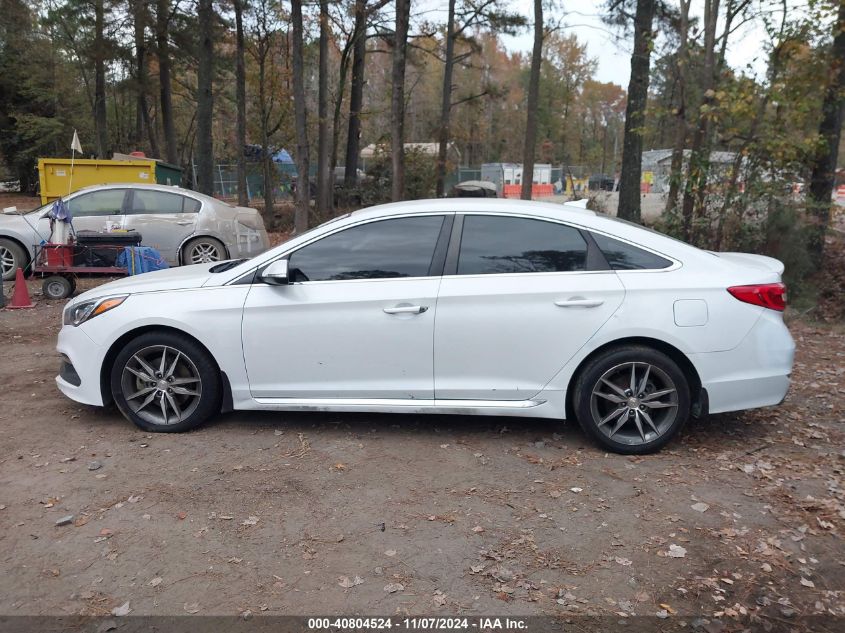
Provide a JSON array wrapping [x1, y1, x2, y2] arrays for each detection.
[[418, 0, 780, 89]]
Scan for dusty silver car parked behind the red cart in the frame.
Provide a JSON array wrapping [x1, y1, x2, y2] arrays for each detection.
[[0, 184, 270, 280]]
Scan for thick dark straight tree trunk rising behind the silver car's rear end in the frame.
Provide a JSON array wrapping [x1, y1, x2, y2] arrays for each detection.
[[197, 0, 214, 196]]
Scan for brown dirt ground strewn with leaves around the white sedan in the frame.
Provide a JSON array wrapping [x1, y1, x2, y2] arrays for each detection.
[[0, 281, 845, 631]]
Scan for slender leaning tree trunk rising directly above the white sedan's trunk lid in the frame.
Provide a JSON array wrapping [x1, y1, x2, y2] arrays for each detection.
[[683, 0, 727, 242]]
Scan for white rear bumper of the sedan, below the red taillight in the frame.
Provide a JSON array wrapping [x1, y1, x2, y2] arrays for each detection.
[[689, 310, 795, 413]]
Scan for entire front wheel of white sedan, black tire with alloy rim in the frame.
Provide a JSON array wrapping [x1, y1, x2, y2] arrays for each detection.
[[110, 331, 223, 433]]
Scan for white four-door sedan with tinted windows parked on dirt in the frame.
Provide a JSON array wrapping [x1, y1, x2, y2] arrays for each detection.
[[56, 198, 794, 453]]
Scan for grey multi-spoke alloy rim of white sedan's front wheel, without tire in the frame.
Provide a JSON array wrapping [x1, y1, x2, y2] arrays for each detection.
[[121, 345, 202, 425]]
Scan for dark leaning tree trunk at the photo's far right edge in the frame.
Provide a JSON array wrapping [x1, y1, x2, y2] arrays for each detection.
[[807, 2, 845, 267]]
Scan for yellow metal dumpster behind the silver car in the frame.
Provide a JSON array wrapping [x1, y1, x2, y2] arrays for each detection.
[[38, 158, 156, 204]]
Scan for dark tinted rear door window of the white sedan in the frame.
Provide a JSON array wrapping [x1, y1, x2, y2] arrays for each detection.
[[458, 215, 587, 275]]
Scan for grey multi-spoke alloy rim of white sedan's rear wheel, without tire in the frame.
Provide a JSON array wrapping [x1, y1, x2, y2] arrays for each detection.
[[590, 362, 678, 445]]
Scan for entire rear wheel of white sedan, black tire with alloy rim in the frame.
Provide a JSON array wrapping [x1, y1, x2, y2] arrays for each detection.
[[572, 345, 690, 455]]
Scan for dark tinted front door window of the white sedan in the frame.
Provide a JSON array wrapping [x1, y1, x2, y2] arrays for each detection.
[[289, 216, 443, 281]]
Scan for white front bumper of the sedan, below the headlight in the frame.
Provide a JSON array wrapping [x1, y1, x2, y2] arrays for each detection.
[[56, 325, 106, 406]]
